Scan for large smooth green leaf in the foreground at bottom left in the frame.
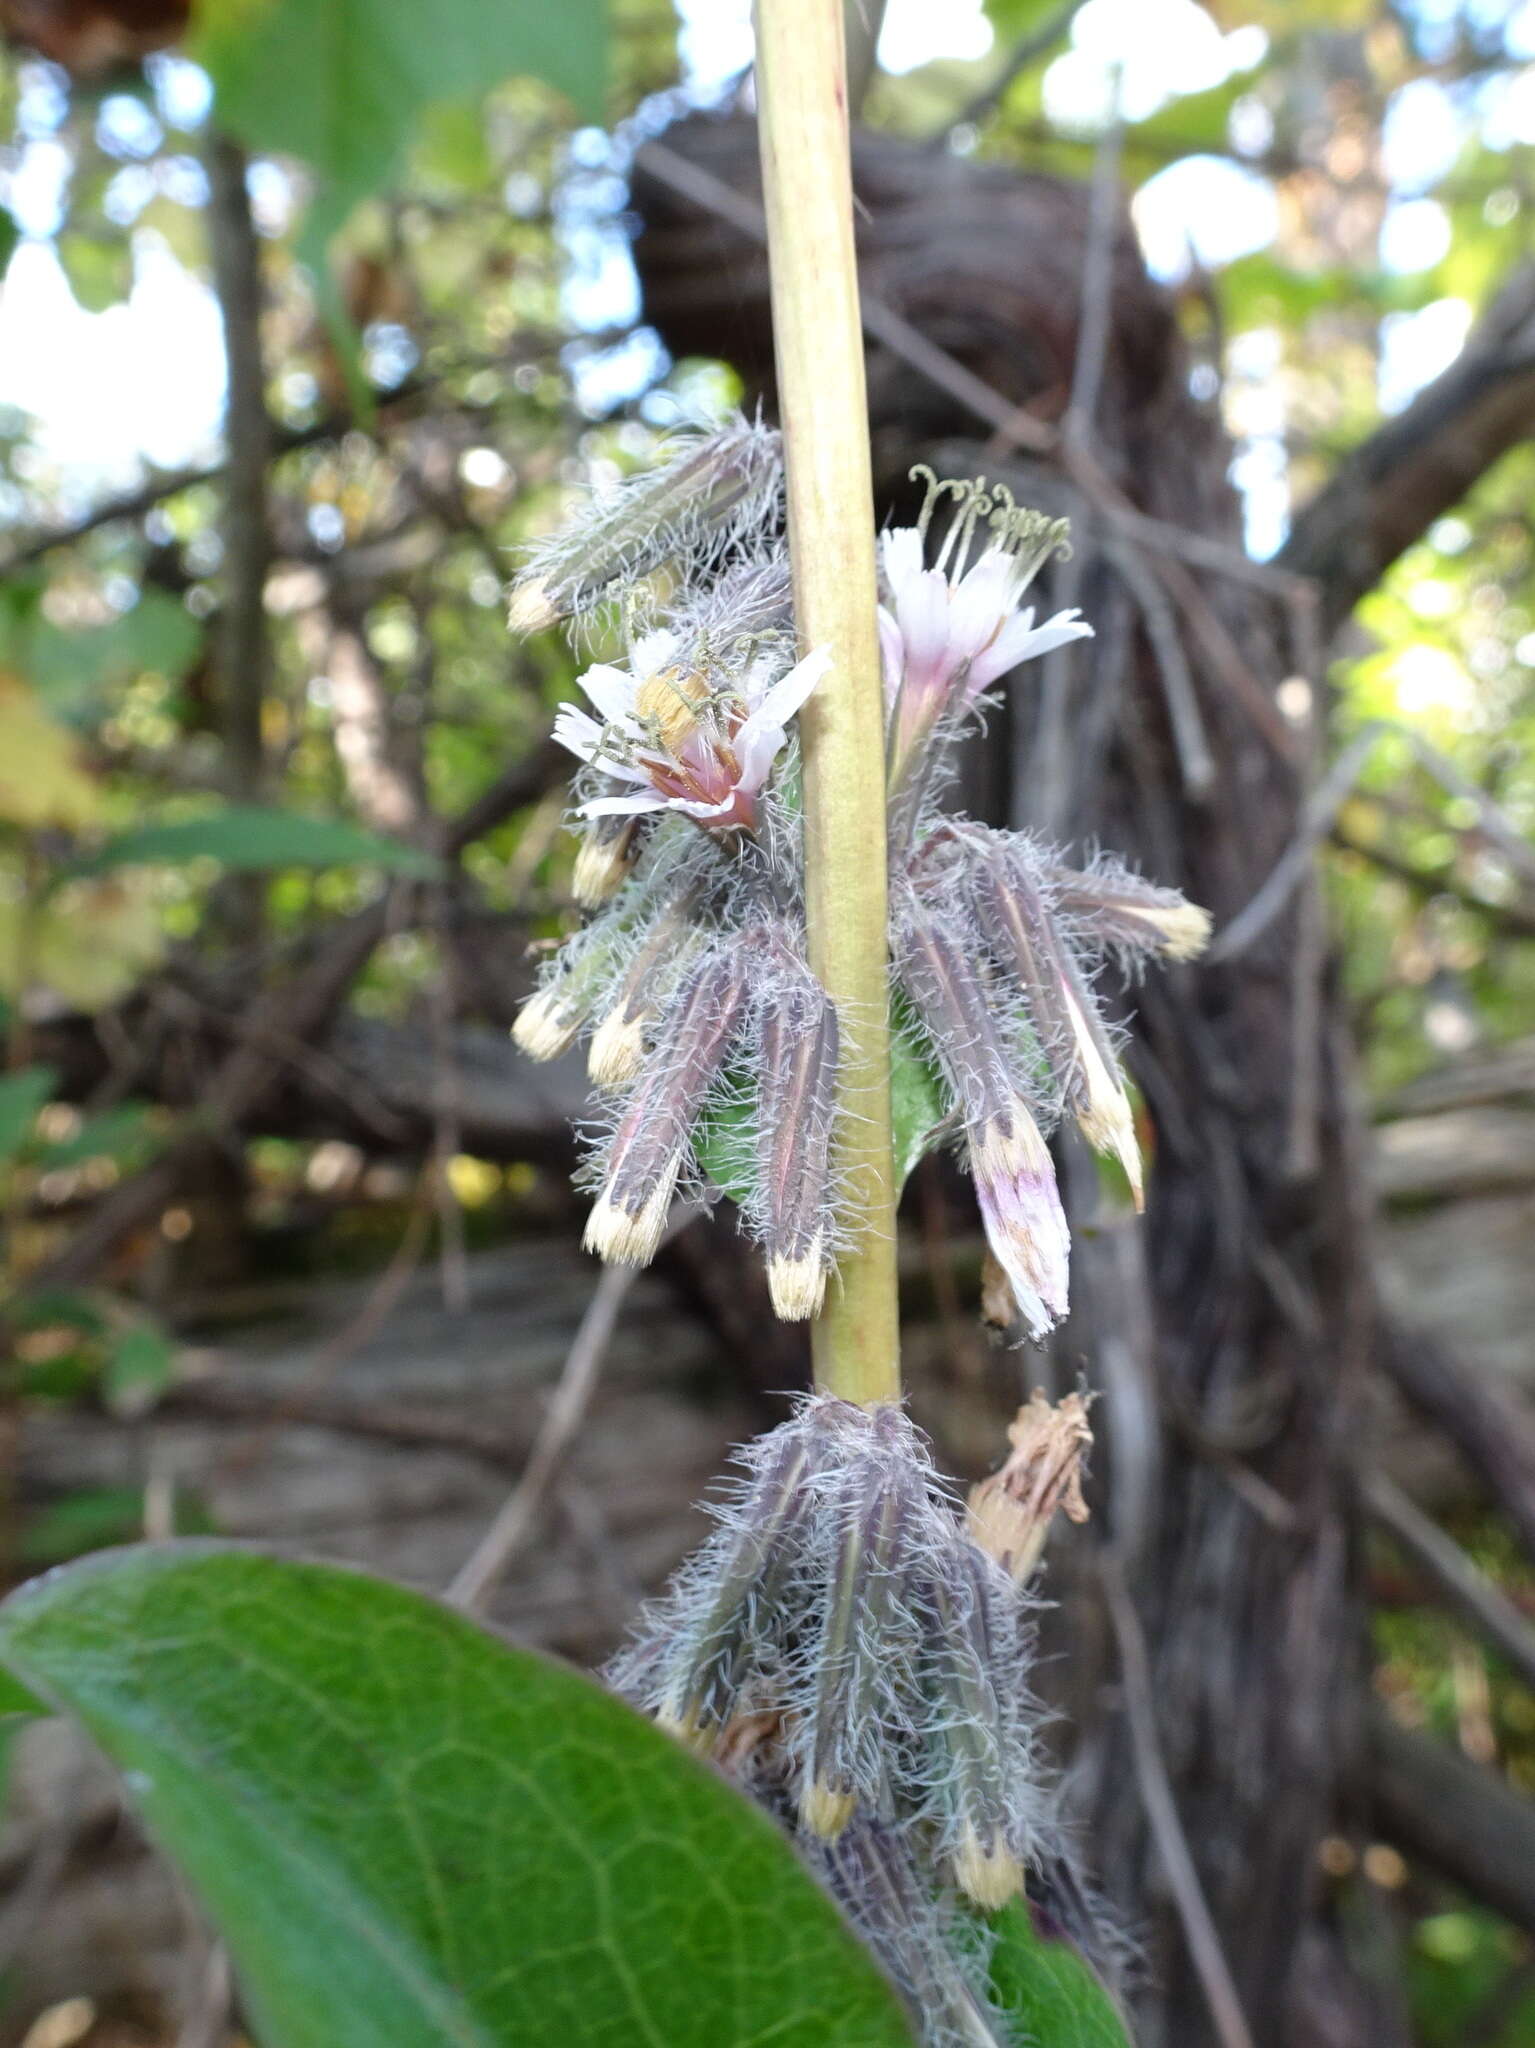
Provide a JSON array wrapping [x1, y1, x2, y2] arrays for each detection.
[[0, 1544, 911, 2048]]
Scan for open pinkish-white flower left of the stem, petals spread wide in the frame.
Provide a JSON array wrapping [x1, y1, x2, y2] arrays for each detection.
[[555, 633, 831, 831]]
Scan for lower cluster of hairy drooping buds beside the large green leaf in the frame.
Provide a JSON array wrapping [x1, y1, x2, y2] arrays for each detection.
[[608, 1397, 1121, 2044]]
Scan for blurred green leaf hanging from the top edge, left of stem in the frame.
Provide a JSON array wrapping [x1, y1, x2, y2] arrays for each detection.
[[192, 0, 606, 223]]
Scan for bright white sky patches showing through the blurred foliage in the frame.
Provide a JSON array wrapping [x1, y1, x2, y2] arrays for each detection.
[[0, 0, 1535, 553]]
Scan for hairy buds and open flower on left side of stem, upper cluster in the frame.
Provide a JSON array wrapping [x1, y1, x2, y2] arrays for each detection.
[[514, 420, 855, 1319]]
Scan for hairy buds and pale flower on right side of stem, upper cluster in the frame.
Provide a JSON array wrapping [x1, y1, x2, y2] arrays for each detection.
[[880, 471, 1210, 1337]]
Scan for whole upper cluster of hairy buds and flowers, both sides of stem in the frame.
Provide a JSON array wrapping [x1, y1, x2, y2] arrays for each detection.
[[512, 420, 1208, 1335]]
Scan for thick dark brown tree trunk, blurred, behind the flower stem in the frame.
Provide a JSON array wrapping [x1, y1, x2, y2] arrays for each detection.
[[637, 123, 1396, 2048]]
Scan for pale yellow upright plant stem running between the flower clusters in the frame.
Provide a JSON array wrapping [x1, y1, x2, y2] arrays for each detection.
[[757, 0, 901, 1405]]
